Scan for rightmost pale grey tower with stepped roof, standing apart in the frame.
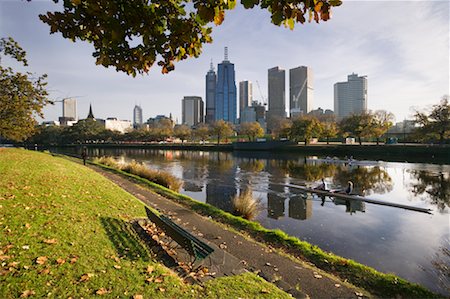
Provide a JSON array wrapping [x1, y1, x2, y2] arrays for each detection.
[[334, 73, 367, 119]]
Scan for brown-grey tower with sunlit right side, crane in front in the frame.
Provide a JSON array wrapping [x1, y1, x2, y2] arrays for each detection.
[[289, 66, 314, 118]]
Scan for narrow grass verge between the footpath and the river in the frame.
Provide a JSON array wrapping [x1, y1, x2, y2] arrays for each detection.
[[92, 158, 443, 298]]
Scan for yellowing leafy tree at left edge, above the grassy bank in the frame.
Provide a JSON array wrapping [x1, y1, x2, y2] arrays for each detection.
[[0, 38, 50, 141]]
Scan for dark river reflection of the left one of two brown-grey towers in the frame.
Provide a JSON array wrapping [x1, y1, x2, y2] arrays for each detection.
[[266, 160, 286, 219]]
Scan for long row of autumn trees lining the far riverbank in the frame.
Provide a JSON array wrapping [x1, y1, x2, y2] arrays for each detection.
[[21, 97, 450, 145]]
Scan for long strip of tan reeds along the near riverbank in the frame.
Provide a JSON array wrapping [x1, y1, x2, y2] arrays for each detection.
[[94, 157, 183, 191]]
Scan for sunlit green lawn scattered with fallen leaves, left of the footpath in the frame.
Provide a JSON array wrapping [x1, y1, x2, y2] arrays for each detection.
[[0, 149, 289, 298]]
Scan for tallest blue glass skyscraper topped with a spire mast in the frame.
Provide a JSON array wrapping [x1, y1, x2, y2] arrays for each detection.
[[215, 47, 237, 124]]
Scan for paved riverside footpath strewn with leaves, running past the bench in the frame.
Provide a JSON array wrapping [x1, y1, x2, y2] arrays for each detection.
[[90, 166, 370, 298]]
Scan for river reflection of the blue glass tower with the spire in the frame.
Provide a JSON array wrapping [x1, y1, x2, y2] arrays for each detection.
[[206, 153, 237, 212]]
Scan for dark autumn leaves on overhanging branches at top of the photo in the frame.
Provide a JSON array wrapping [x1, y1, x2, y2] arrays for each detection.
[[40, 0, 341, 76]]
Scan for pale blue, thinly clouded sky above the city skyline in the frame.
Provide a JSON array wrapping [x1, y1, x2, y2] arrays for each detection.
[[0, 0, 450, 121]]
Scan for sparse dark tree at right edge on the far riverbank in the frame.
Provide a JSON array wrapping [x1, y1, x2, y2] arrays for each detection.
[[414, 96, 450, 143]]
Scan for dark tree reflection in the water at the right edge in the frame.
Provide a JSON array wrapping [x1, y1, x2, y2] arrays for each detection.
[[410, 170, 450, 212]]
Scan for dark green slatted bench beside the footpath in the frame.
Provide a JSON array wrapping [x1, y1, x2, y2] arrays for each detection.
[[145, 207, 214, 264]]
